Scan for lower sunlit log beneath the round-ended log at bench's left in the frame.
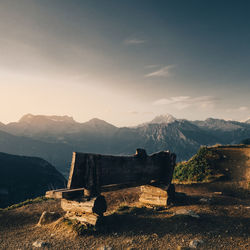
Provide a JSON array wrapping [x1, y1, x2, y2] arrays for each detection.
[[65, 212, 103, 226]]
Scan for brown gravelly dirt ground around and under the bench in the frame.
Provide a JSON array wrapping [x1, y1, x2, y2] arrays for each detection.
[[0, 186, 250, 249]]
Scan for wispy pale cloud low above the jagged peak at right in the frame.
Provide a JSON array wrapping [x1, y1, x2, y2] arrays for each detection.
[[153, 96, 218, 110]]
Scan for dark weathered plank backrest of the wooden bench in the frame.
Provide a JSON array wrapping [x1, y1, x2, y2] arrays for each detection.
[[68, 149, 176, 197]]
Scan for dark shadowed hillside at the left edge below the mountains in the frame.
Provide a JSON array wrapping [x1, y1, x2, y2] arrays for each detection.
[[0, 153, 66, 207]]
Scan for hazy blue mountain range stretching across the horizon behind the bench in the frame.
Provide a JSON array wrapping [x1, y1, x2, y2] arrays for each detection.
[[0, 114, 250, 175]]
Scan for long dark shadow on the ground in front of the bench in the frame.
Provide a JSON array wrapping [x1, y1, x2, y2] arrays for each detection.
[[89, 208, 250, 237]]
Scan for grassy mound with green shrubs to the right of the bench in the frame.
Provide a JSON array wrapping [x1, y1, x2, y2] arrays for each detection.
[[173, 145, 250, 182]]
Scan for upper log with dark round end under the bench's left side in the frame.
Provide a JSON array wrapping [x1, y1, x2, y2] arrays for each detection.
[[61, 195, 107, 216]]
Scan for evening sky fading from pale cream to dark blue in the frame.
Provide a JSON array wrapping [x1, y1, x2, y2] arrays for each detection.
[[0, 0, 250, 126]]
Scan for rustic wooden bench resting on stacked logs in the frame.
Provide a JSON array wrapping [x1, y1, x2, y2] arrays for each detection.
[[46, 149, 176, 225]]
